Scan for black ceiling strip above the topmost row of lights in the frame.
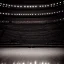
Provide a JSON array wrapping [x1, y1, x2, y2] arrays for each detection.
[[0, 0, 62, 4]]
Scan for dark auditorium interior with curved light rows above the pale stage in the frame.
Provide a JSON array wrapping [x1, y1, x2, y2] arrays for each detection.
[[0, 0, 64, 46]]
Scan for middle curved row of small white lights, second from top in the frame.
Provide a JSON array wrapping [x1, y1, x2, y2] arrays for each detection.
[[0, 10, 64, 16]]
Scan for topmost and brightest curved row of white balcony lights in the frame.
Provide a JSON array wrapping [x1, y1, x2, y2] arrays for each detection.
[[0, 1, 64, 8]]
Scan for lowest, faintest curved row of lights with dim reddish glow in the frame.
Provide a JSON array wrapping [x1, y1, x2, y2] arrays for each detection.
[[0, 18, 64, 24]]
